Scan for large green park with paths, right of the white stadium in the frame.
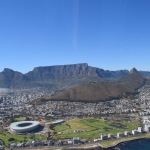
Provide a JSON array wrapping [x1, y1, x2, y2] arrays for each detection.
[[54, 117, 141, 140]]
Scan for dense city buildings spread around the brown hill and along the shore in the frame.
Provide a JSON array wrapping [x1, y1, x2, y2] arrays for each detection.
[[0, 81, 150, 149]]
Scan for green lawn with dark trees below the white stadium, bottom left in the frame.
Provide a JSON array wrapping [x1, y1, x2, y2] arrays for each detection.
[[0, 131, 46, 146]]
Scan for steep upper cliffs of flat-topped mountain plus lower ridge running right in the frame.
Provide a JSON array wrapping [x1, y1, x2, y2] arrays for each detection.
[[26, 63, 128, 80]]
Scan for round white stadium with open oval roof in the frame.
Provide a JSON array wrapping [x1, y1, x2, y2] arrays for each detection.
[[10, 121, 39, 133]]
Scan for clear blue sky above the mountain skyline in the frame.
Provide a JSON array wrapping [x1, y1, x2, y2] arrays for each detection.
[[0, 0, 150, 73]]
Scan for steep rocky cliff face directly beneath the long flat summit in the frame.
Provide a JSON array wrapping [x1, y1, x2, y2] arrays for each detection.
[[26, 64, 98, 80]]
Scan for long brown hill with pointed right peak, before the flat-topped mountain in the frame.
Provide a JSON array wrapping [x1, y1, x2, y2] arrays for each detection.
[[40, 68, 146, 102]]
